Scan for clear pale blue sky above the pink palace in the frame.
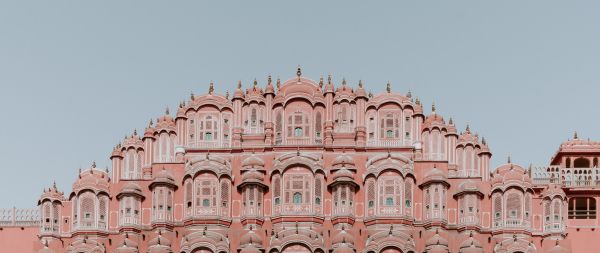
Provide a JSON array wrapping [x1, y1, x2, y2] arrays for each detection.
[[0, 1, 600, 207]]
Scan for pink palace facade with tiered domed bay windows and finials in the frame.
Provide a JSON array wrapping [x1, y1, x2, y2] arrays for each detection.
[[0, 69, 600, 253]]
